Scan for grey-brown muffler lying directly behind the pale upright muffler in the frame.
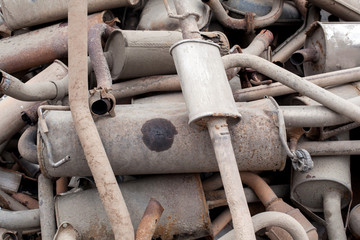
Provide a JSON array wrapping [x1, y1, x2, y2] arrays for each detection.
[[105, 30, 230, 80]]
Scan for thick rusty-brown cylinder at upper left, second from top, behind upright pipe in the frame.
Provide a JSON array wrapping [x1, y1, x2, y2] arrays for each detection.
[[0, 11, 114, 73]]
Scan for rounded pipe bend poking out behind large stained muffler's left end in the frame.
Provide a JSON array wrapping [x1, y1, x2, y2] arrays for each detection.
[[18, 126, 39, 164]]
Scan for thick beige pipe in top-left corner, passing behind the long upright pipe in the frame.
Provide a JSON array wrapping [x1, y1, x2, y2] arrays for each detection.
[[0, 0, 139, 30]]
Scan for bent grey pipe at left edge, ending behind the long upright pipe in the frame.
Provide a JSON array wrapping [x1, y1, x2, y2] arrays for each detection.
[[0, 70, 68, 102]]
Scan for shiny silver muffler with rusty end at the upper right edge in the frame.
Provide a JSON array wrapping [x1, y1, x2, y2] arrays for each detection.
[[304, 22, 360, 76]]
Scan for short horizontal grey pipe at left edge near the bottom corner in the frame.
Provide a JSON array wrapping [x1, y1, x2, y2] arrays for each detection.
[[0, 209, 40, 230]]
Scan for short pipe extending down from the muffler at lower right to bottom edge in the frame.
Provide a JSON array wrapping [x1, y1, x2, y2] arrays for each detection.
[[323, 190, 347, 240]]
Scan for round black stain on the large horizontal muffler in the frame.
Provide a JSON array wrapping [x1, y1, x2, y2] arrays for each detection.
[[141, 118, 177, 152]]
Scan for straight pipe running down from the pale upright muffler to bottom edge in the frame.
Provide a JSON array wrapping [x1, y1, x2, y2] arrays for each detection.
[[207, 118, 255, 240]]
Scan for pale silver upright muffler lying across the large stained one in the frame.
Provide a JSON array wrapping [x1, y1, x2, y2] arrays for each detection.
[[170, 39, 241, 124]]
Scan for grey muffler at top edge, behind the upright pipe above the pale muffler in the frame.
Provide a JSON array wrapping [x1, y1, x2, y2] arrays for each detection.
[[137, 0, 210, 31]]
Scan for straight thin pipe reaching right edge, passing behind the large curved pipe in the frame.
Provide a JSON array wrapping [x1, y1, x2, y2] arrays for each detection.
[[234, 67, 360, 102]]
